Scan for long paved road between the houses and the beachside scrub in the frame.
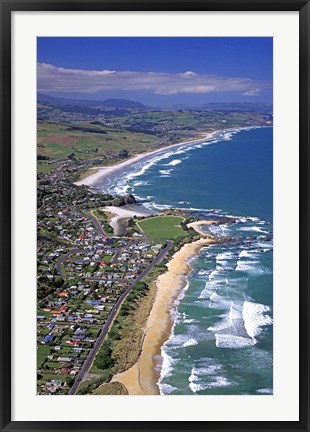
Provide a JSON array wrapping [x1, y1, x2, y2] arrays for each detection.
[[68, 241, 173, 395]]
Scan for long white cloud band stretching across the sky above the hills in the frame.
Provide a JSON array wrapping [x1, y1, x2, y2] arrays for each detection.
[[38, 63, 270, 96]]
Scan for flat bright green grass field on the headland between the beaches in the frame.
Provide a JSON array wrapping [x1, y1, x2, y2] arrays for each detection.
[[137, 216, 186, 240]]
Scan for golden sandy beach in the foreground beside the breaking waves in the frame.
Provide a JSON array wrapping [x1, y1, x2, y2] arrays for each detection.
[[113, 233, 219, 395]]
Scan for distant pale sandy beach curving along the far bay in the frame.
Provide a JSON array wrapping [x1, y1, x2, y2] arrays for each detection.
[[75, 131, 219, 187]]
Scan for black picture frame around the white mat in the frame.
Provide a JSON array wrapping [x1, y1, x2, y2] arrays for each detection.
[[0, 0, 310, 432]]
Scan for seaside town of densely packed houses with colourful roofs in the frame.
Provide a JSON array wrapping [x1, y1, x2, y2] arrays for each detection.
[[37, 160, 190, 395]]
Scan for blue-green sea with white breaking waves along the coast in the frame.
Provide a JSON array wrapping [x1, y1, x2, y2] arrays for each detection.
[[98, 127, 273, 395]]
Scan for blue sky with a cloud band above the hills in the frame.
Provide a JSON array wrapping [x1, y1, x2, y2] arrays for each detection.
[[37, 37, 273, 106]]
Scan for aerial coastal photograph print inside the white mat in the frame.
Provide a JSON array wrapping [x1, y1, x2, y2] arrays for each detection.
[[34, 37, 273, 396]]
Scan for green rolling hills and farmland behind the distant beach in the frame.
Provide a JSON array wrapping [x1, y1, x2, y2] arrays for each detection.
[[37, 104, 271, 165]]
